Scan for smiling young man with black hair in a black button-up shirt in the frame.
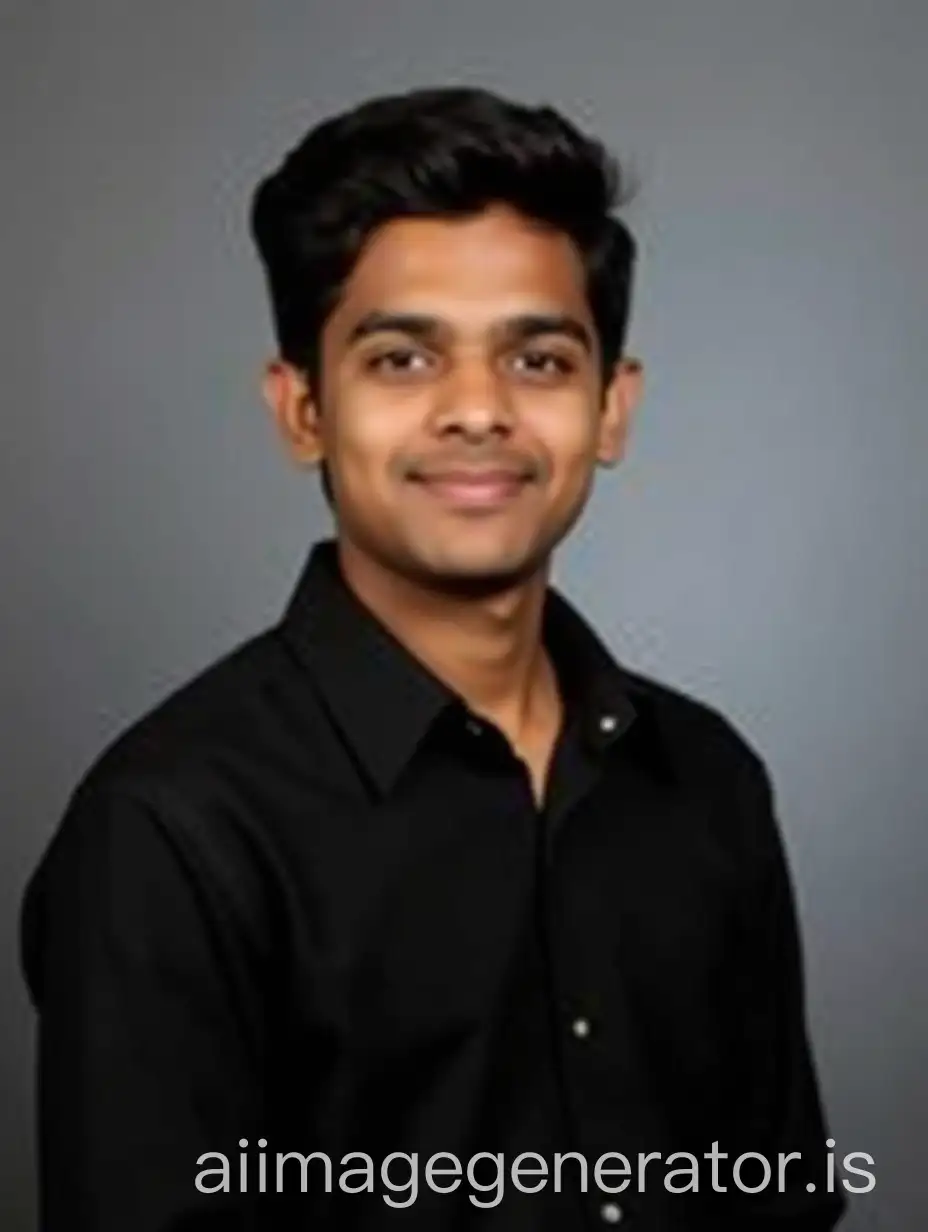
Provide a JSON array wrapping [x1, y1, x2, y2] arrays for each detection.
[[23, 89, 842, 1232]]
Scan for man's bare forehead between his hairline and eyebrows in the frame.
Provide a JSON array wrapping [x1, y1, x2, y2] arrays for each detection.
[[333, 207, 589, 326]]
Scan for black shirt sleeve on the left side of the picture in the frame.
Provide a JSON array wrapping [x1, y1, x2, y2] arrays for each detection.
[[21, 785, 269, 1232]]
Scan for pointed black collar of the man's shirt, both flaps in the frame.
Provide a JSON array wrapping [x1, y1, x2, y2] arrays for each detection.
[[279, 538, 636, 793]]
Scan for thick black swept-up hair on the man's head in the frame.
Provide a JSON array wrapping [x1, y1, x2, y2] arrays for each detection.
[[250, 86, 636, 495]]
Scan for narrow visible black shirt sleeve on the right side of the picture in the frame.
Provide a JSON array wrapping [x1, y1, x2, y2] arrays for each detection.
[[733, 752, 847, 1232]]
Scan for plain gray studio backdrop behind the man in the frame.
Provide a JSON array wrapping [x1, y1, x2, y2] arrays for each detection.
[[0, 0, 928, 1232]]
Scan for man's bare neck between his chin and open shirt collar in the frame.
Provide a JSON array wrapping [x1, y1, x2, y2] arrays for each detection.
[[339, 540, 560, 744]]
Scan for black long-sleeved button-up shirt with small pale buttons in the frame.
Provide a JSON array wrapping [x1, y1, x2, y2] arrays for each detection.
[[21, 541, 843, 1232]]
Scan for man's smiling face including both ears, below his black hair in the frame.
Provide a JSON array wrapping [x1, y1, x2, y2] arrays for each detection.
[[266, 207, 636, 586]]
